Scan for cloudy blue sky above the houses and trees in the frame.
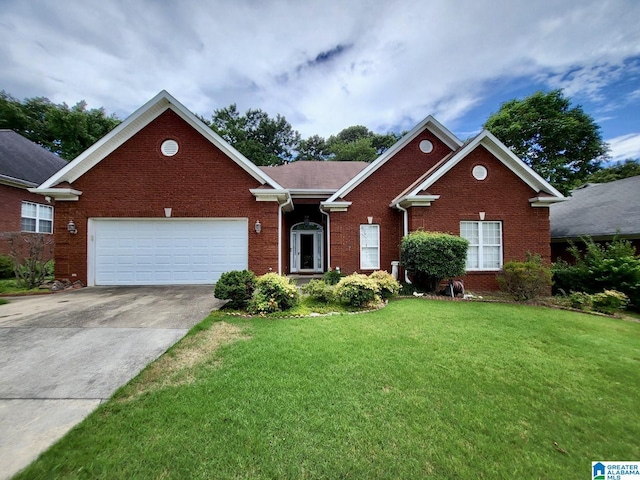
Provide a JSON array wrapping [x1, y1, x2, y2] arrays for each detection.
[[0, 0, 640, 161]]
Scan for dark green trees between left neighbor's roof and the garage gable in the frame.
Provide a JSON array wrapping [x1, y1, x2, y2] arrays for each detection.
[[0, 91, 120, 160]]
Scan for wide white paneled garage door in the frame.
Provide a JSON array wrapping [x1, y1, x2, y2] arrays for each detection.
[[89, 218, 249, 285]]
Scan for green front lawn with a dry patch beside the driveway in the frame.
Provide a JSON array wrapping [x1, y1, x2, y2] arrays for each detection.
[[18, 299, 640, 479]]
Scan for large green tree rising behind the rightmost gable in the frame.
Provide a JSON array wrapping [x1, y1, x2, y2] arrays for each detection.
[[484, 90, 608, 194]]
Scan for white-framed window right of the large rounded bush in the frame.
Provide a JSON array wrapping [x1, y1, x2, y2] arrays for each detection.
[[460, 222, 502, 270]]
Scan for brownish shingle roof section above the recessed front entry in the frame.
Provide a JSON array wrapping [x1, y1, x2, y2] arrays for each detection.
[[260, 161, 369, 190]]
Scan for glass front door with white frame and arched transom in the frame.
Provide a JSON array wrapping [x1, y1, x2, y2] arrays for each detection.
[[291, 222, 324, 273]]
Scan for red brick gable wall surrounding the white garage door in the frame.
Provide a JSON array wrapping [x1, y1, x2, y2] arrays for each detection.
[[54, 110, 279, 282]]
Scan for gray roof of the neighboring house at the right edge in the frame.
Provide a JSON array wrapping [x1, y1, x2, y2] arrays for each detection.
[[549, 176, 640, 239]]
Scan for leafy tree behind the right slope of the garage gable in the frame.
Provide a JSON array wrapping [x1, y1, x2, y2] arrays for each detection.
[[206, 103, 300, 165]]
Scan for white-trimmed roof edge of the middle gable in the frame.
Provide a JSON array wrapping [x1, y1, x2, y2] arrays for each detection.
[[325, 115, 462, 203]]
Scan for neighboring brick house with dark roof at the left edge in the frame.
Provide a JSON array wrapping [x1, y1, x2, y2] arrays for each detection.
[[0, 129, 67, 255]]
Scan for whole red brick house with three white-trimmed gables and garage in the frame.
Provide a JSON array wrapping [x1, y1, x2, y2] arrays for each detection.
[[33, 91, 564, 290]]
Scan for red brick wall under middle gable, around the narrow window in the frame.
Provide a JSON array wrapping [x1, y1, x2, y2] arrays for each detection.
[[330, 131, 451, 273]]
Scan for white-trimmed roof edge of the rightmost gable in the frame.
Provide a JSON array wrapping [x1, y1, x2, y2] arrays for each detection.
[[391, 130, 564, 206]]
